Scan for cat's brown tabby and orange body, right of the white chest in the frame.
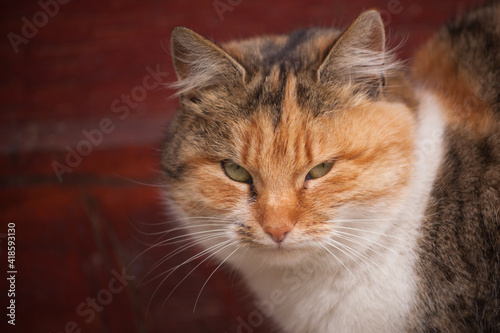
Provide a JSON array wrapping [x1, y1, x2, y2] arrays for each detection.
[[413, 3, 500, 332]]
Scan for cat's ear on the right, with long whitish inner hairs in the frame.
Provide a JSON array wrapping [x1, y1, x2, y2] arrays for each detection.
[[318, 10, 391, 96]]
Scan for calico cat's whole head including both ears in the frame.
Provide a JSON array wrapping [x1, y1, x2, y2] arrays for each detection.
[[162, 11, 416, 265]]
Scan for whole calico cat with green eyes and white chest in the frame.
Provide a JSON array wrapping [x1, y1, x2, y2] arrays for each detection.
[[161, 2, 500, 333]]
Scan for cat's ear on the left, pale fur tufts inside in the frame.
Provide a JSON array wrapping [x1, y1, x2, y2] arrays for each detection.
[[171, 27, 246, 94]]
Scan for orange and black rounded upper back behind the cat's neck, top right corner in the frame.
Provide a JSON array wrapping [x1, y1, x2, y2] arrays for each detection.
[[413, 1, 500, 136]]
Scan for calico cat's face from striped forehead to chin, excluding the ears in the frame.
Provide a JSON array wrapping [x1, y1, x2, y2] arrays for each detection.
[[164, 11, 415, 265]]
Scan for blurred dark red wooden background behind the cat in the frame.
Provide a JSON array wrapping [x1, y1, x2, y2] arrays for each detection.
[[0, 0, 488, 333]]
